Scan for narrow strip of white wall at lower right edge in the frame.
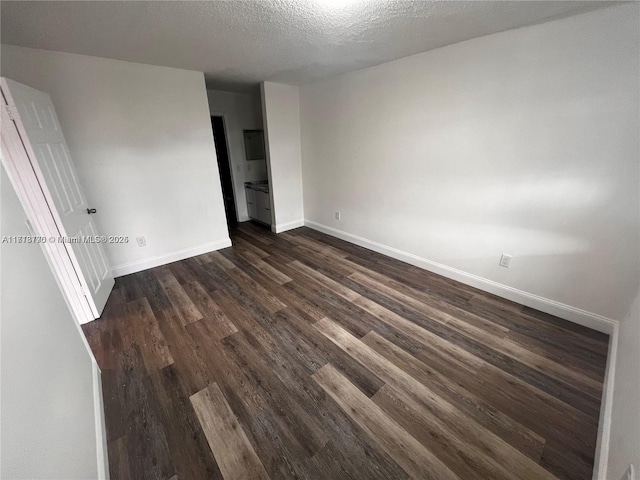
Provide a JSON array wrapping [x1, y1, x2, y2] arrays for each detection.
[[606, 292, 640, 479]]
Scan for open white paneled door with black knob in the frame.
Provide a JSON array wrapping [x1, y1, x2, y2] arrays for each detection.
[[2, 78, 114, 323]]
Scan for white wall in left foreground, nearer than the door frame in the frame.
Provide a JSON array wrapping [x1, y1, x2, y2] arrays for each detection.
[[0, 167, 98, 480]]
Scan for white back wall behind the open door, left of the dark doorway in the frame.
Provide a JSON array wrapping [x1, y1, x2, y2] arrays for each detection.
[[2, 45, 230, 276]]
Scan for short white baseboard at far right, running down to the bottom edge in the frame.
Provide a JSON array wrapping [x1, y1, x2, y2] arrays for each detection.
[[592, 323, 619, 480]]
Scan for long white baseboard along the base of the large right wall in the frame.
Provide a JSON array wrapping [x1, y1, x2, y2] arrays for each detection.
[[304, 220, 618, 335]]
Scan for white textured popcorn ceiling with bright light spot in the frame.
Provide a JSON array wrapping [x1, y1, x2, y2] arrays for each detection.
[[1, 0, 612, 91]]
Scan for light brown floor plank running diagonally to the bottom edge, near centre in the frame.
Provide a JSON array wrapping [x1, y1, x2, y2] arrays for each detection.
[[313, 364, 459, 480]]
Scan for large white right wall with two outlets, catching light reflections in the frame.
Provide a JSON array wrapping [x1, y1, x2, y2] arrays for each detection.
[[300, 3, 640, 319]]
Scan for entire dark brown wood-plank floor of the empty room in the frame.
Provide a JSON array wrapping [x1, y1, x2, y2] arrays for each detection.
[[83, 223, 608, 480]]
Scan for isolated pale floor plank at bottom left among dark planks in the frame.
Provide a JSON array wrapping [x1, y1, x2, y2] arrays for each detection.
[[190, 383, 269, 480]]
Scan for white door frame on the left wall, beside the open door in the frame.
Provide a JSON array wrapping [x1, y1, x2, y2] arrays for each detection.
[[0, 87, 97, 325]]
